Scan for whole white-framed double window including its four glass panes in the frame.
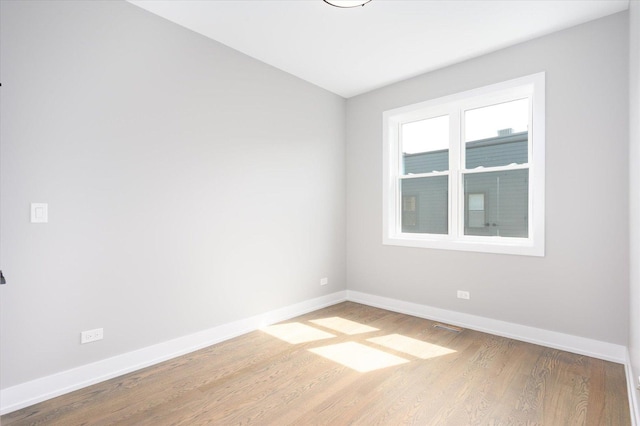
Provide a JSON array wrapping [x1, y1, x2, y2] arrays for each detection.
[[383, 73, 544, 256]]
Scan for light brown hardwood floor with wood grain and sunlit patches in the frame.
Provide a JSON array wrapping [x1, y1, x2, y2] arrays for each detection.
[[1, 302, 630, 426]]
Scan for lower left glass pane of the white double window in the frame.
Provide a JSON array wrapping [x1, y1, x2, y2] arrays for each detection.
[[401, 176, 449, 234]]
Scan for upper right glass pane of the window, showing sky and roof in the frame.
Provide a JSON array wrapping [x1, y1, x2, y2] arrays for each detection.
[[464, 99, 529, 169]]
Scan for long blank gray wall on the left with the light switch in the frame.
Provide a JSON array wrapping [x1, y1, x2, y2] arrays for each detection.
[[0, 1, 346, 388]]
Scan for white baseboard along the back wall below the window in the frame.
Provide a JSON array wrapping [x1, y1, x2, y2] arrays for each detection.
[[347, 290, 628, 364]]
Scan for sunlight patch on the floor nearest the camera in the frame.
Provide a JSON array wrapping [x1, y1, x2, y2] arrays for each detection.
[[309, 342, 409, 373]]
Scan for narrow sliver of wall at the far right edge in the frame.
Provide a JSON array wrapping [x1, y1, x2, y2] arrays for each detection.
[[629, 0, 640, 421]]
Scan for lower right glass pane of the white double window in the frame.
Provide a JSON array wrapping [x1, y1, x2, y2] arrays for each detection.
[[464, 170, 529, 238]]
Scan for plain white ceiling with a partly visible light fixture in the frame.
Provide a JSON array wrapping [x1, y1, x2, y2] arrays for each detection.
[[130, 0, 629, 98]]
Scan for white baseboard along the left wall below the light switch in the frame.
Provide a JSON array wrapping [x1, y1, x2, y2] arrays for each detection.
[[0, 291, 346, 414]]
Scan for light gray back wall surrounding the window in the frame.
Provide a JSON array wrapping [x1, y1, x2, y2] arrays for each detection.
[[347, 13, 629, 345]]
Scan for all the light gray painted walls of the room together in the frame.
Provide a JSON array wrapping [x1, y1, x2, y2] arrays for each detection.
[[0, 1, 640, 402]]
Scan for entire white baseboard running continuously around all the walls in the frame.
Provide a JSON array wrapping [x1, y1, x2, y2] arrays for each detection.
[[0, 290, 640, 416]]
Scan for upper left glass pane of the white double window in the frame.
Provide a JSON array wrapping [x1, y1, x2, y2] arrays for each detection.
[[402, 115, 449, 175]]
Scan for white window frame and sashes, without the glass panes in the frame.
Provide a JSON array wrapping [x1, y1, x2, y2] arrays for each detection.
[[383, 72, 545, 256]]
